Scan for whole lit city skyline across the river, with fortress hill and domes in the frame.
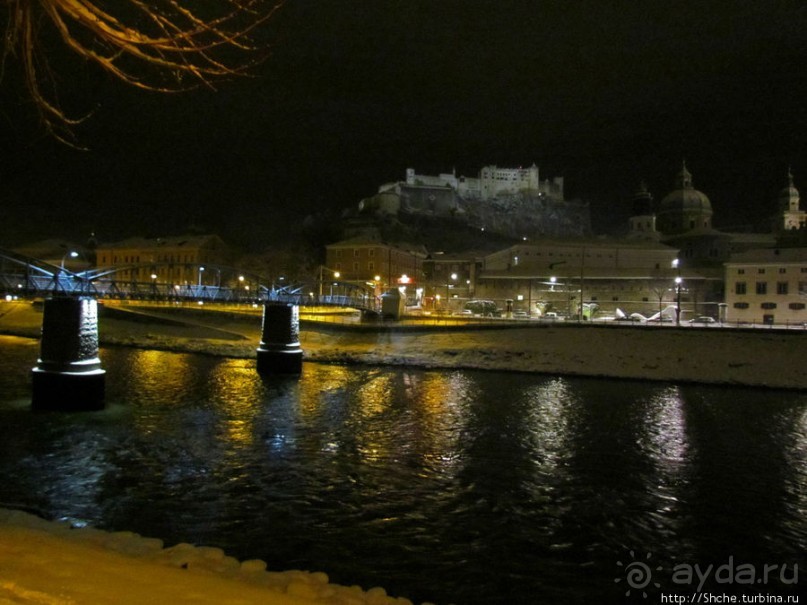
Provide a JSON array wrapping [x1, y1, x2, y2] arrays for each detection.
[[6, 163, 807, 324]]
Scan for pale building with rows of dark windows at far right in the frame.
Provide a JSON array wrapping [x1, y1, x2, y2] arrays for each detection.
[[725, 248, 807, 325]]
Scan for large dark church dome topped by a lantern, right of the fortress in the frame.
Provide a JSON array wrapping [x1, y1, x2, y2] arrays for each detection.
[[656, 163, 712, 236]]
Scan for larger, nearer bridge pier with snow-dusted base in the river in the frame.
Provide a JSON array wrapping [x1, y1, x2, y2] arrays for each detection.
[[31, 297, 106, 411]]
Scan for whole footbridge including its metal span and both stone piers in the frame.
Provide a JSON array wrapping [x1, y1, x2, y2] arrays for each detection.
[[0, 249, 370, 411]]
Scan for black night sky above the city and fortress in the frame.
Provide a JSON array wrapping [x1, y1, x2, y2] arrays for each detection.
[[0, 0, 807, 246]]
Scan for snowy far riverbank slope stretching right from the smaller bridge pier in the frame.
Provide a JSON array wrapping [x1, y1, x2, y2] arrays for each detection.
[[303, 324, 807, 389]]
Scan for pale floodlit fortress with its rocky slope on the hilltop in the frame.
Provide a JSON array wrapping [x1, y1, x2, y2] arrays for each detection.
[[359, 164, 591, 238]]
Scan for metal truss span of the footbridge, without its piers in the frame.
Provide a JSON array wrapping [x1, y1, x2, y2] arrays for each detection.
[[0, 248, 380, 312]]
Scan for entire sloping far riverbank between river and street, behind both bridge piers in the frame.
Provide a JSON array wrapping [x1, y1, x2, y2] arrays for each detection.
[[0, 303, 807, 389]]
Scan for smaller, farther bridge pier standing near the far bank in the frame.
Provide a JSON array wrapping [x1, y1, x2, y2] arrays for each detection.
[[257, 303, 303, 374]]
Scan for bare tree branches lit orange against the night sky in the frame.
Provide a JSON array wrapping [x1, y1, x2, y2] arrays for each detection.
[[0, 0, 283, 146]]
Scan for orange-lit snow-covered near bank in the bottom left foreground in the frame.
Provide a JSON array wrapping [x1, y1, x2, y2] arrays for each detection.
[[0, 509, 426, 605]]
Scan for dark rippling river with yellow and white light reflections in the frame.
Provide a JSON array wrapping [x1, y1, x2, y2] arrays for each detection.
[[0, 337, 807, 605]]
